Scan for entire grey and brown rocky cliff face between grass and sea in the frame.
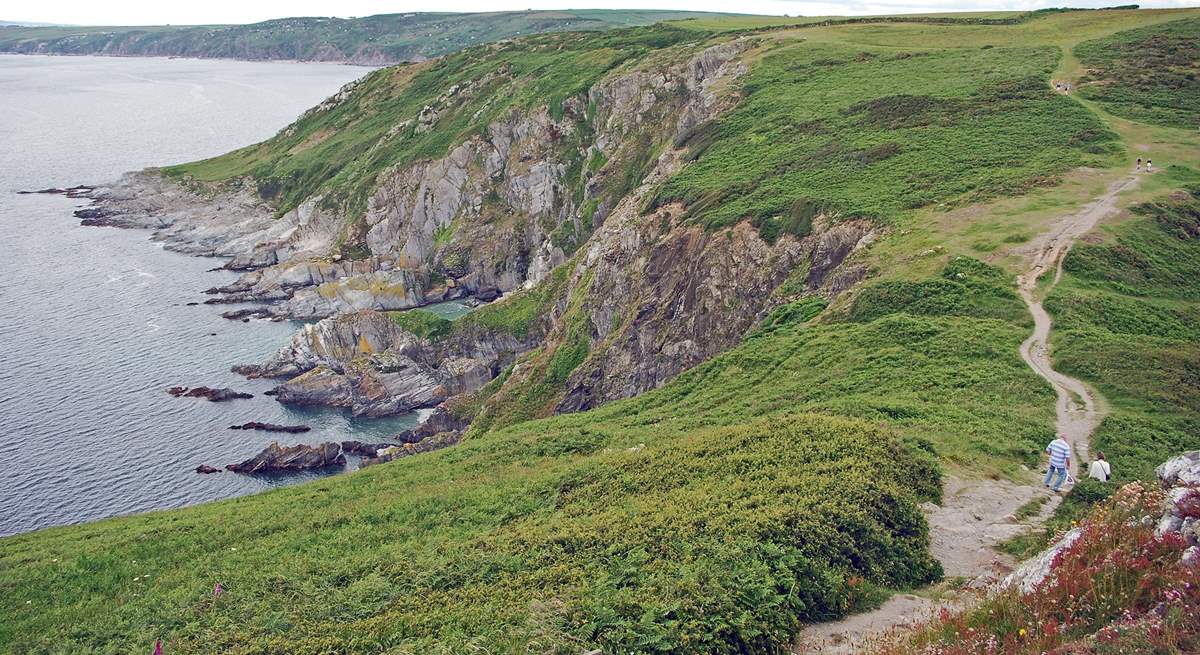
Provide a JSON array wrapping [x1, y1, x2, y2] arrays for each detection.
[[82, 38, 875, 431]]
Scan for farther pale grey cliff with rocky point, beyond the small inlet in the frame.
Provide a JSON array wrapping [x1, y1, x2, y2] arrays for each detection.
[[80, 41, 746, 318]]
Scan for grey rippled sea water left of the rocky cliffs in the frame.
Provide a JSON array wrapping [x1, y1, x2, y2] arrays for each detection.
[[0, 55, 416, 535]]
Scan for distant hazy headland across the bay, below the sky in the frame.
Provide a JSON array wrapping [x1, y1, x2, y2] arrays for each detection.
[[0, 10, 720, 61]]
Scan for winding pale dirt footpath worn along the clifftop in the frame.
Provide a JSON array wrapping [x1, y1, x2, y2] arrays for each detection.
[[794, 170, 1138, 655]]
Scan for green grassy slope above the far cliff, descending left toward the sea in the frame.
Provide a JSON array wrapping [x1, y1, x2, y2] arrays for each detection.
[[167, 26, 696, 221]]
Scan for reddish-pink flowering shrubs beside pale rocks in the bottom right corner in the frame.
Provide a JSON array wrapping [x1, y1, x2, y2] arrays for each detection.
[[875, 482, 1200, 655]]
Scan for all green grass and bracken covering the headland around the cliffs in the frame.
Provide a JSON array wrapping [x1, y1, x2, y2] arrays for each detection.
[[0, 6, 1200, 654]]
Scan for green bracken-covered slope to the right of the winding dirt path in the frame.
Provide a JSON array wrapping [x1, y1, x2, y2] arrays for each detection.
[[1046, 181, 1200, 481]]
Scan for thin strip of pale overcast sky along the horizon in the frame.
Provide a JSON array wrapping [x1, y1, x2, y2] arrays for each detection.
[[0, 0, 1200, 25]]
